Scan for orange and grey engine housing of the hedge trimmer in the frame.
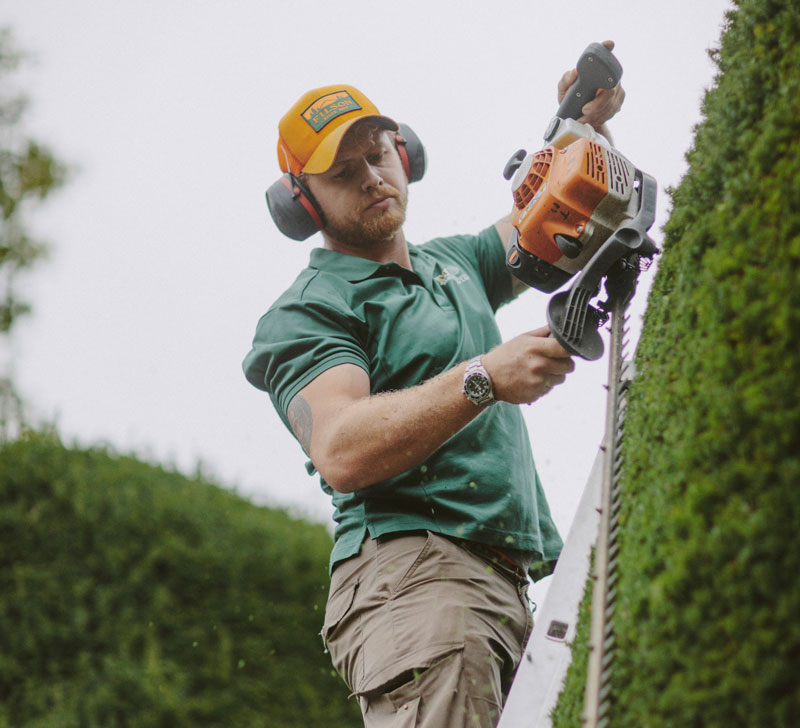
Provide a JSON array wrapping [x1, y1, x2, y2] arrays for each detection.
[[511, 138, 636, 276]]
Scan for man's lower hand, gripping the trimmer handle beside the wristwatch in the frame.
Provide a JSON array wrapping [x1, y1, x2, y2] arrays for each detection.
[[483, 327, 575, 404]]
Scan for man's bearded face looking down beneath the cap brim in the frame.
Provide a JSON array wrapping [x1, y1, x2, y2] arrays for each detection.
[[306, 123, 408, 248]]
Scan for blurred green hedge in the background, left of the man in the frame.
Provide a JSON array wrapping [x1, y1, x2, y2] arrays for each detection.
[[0, 434, 359, 728]]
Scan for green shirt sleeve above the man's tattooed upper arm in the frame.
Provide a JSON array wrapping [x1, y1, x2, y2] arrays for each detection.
[[242, 299, 369, 421]]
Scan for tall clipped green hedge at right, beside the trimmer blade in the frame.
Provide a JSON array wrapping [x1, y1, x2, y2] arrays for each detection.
[[558, 0, 800, 728]]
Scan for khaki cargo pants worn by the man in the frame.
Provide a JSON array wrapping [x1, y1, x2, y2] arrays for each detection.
[[322, 531, 533, 728]]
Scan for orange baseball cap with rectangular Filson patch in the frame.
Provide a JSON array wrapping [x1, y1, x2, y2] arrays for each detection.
[[278, 84, 398, 175]]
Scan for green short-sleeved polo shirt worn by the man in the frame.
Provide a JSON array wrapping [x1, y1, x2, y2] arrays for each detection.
[[243, 226, 561, 578]]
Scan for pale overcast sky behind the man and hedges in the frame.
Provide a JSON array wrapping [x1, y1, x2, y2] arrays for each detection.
[[0, 0, 730, 596]]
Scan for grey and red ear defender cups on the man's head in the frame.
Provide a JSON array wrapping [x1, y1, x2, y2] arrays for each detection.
[[267, 124, 427, 240]]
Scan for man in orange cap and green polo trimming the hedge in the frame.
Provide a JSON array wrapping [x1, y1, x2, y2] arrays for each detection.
[[244, 48, 624, 728]]
